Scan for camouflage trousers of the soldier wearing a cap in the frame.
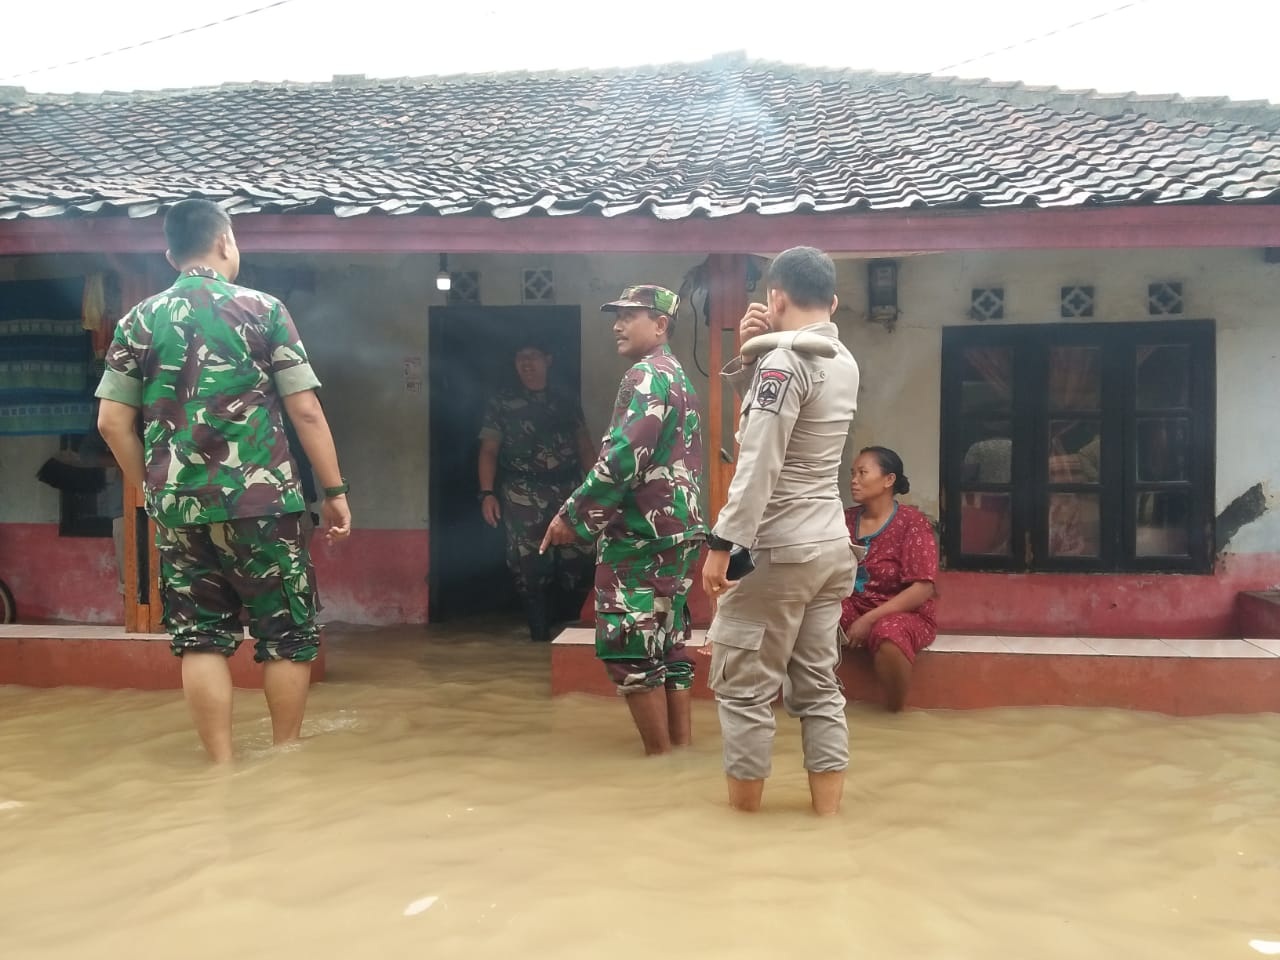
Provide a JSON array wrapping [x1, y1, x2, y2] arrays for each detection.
[[595, 541, 700, 695]]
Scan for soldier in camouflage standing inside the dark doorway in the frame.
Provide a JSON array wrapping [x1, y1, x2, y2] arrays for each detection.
[[479, 340, 595, 641]]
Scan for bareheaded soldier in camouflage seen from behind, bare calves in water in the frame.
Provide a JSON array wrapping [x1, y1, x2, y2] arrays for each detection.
[[97, 200, 351, 762]]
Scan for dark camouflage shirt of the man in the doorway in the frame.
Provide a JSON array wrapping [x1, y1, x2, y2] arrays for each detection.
[[480, 389, 582, 481]]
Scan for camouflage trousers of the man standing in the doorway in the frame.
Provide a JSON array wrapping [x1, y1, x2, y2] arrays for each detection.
[[499, 480, 595, 602]]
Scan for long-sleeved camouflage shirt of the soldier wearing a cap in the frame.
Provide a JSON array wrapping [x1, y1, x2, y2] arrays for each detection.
[[561, 346, 707, 552]]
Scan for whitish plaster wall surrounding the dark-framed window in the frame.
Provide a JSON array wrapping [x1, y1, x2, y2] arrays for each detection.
[[837, 250, 1280, 553]]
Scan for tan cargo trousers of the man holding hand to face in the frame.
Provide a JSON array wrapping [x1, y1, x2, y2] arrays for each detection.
[[708, 538, 858, 780]]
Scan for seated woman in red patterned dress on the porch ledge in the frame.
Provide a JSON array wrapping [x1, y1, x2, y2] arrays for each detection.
[[840, 447, 938, 713]]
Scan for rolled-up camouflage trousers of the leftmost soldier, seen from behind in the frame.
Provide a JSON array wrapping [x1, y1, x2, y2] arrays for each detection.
[[156, 513, 320, 663]]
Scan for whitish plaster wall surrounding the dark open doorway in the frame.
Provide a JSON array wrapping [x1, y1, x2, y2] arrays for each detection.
[[262, 255, 707, 529]]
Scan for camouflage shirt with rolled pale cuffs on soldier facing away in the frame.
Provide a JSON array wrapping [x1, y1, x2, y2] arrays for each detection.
[[97, 268, 320, 527]]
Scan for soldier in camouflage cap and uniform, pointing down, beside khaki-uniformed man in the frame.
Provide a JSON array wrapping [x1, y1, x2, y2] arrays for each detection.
[[543, 285, 707, 754]]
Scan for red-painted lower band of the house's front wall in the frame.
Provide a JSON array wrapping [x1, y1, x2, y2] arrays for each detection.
[[0, 524, 1280, 639]]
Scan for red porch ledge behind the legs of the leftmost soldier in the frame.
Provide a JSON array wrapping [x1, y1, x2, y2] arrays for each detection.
[[0, 623, 325, 690]]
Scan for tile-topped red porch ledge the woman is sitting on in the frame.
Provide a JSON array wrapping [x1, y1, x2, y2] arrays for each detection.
[[552, 627, 1280, 717]]
